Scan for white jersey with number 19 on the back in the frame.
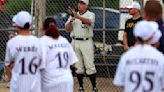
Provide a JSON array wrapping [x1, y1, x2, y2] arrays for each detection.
[[40, 36, 78, 88]]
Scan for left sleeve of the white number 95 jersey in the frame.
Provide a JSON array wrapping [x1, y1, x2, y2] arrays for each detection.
[[113, 54, 126, 86]]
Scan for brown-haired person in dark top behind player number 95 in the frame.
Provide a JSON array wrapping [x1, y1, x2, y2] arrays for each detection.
[[144, 0, 164, 54]]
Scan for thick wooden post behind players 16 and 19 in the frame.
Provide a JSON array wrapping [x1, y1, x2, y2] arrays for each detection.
[[35, 0, 46, 36]]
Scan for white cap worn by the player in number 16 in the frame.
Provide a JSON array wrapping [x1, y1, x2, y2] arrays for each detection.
[[12, 11, 32, 28]]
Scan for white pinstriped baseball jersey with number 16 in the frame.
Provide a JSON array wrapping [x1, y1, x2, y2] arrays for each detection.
[[5, 35, 44, 92]]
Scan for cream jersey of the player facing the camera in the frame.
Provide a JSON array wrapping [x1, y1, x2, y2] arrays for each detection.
[[66, 10, 95, 38]]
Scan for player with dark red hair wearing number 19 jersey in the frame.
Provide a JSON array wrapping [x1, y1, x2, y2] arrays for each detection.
[[40, 17, 78, 92]]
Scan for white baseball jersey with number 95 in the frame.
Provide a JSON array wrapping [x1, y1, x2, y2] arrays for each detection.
[[113, 45, 164, 92]]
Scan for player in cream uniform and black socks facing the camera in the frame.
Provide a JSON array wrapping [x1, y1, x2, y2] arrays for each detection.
[[65, 0, 97, 92]]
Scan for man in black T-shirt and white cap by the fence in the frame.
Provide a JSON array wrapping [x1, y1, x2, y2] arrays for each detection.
[[123, 1, 142, 51]]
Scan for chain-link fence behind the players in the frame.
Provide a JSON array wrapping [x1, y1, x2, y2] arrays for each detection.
[[0, 0, 149, 92]]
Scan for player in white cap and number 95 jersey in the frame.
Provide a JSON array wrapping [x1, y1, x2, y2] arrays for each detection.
[[113, 21, 164, 92]]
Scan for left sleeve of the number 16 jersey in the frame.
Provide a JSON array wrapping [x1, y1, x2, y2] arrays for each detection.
[[5, 43, 13, 66]]
